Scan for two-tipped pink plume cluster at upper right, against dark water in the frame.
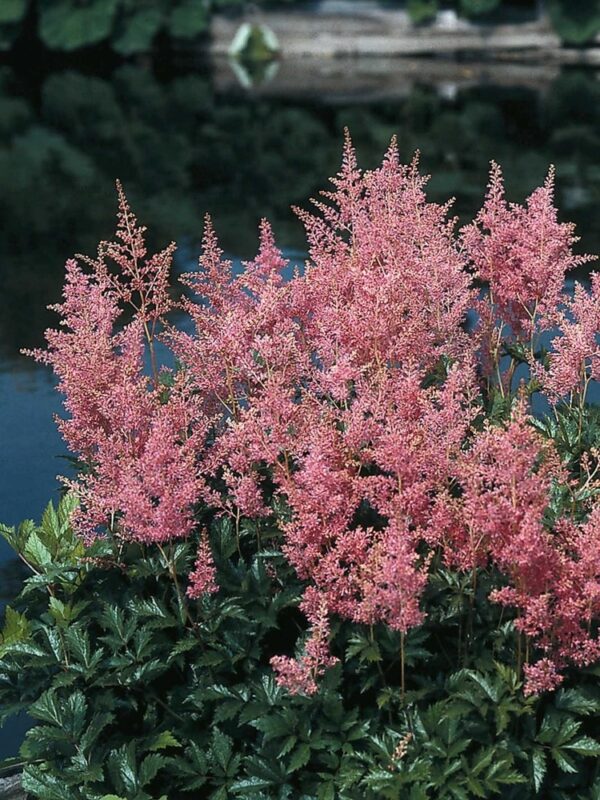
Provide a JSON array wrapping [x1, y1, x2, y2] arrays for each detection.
[[462, 163, 590, 339]]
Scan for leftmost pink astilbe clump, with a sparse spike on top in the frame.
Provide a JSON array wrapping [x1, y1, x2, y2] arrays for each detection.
[[27, 192, 204, 542]]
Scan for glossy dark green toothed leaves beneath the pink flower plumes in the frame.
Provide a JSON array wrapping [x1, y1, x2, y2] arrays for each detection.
[[0, 497, 600, 800]]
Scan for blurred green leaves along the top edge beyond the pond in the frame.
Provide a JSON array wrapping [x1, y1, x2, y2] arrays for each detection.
[[0, 0, 600, 51]]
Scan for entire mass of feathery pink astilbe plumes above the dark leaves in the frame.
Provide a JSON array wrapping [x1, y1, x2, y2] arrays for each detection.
[[35, 131, 600, 693]]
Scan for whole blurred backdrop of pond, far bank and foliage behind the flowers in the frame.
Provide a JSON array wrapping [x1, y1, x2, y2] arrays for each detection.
[[0, 0, 600, 756]]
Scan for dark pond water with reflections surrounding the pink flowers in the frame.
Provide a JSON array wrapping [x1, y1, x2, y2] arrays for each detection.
[[0, 54, 600, 756]]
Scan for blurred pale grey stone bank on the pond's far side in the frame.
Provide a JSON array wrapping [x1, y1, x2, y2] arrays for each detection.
[[209, 0, 600, 65]]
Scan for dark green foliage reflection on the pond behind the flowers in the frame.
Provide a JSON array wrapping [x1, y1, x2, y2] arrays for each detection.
[[0, 65, 600, 362]]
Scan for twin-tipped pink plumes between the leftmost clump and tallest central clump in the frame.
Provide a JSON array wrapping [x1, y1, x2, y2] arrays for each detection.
[[167, 212, 307, 515]]
